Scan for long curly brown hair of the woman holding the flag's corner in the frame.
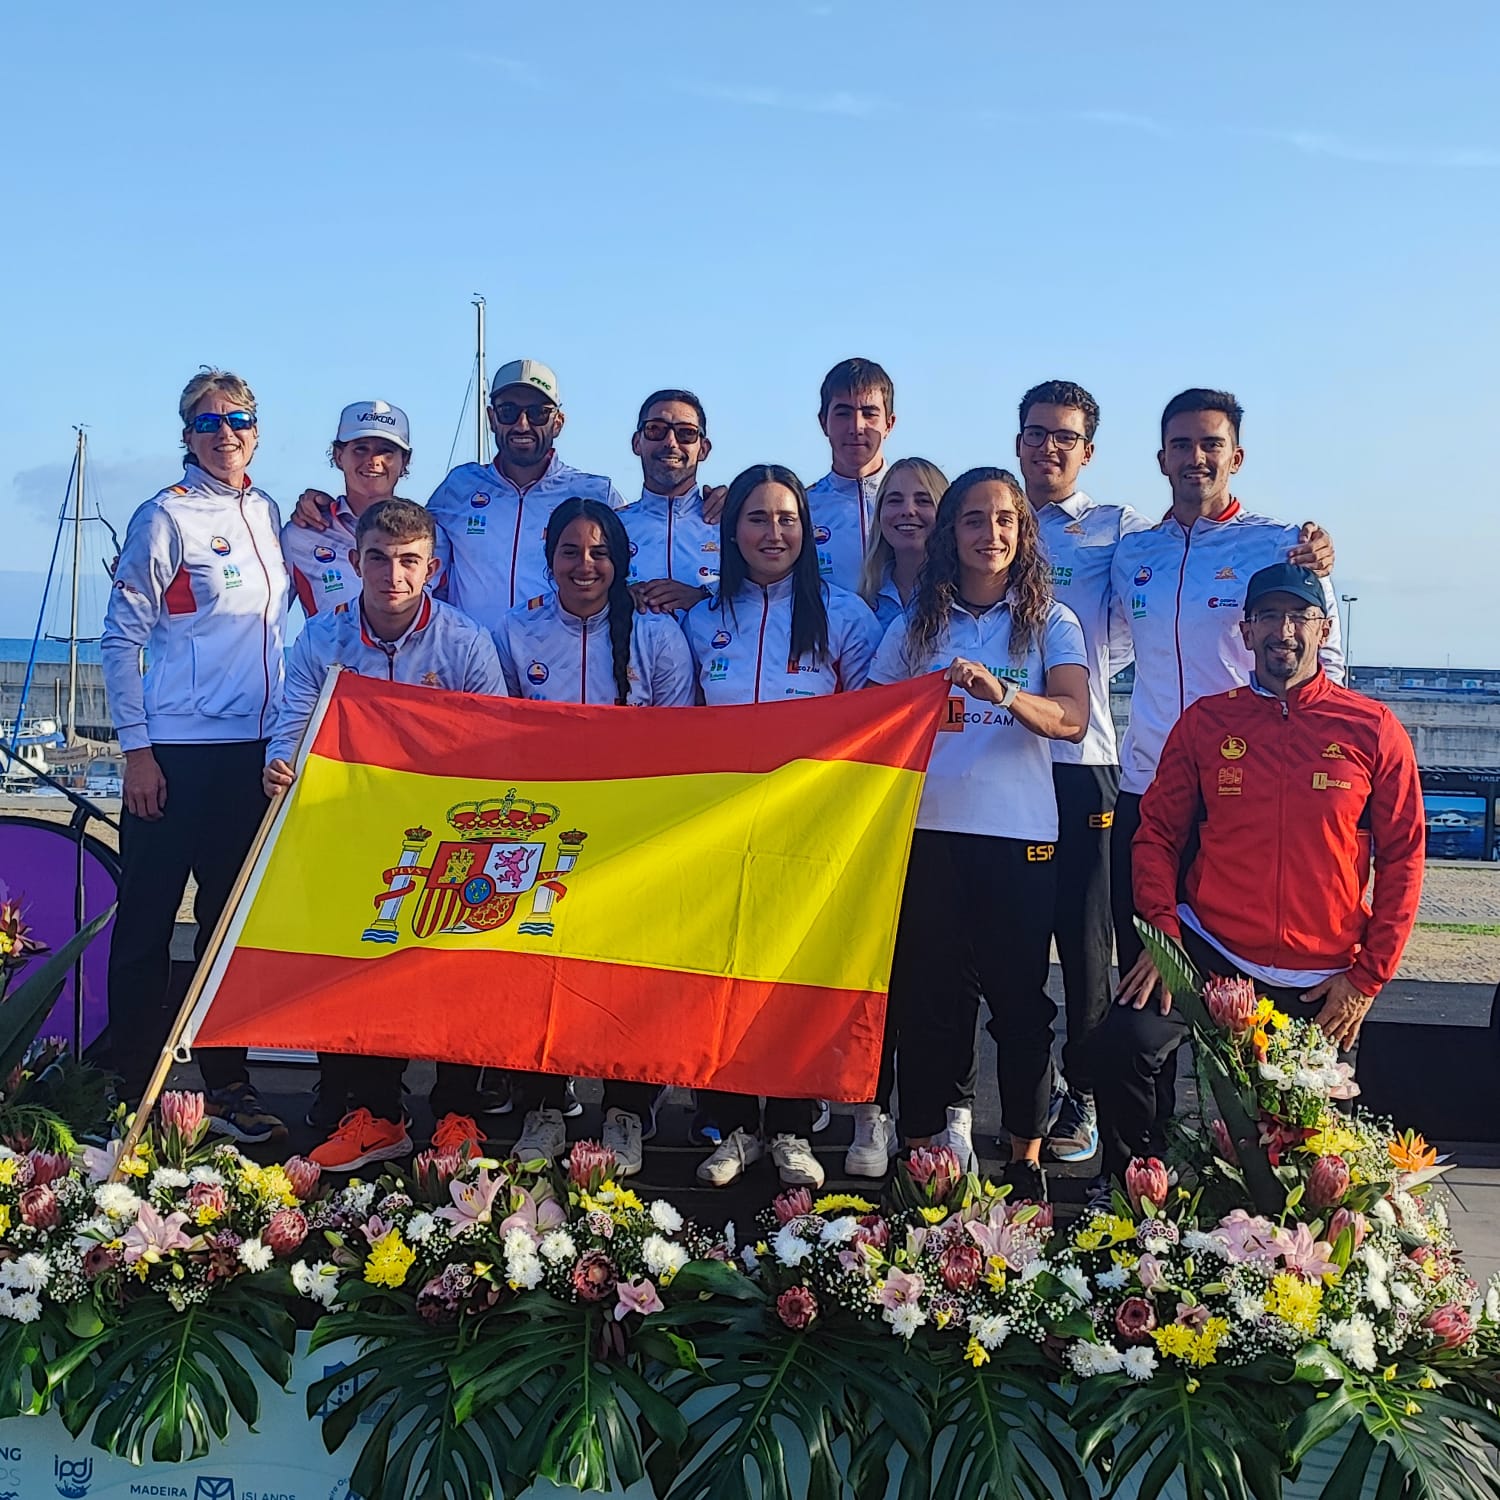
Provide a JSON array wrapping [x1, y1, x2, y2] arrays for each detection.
[[906, 468, 1052, 662]]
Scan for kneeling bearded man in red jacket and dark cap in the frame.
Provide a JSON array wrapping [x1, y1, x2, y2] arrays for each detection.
[[1097, 563, 1425, 1181]]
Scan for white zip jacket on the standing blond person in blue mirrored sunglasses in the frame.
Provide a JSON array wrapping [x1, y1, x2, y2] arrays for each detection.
[[101, 464, 290, 750]]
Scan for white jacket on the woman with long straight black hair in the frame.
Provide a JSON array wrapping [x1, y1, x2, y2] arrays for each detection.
[[684, 578, 881, 704]]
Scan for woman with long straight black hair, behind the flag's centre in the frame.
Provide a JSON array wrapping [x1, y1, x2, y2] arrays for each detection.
[[687, 464, 879, 1188]]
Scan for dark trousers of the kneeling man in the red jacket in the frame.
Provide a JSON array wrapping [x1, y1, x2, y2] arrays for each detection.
[[1094, 927, 1353, 1178]]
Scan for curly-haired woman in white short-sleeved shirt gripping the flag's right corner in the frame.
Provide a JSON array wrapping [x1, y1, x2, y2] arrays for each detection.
[[869, 468, 1089, 1202]]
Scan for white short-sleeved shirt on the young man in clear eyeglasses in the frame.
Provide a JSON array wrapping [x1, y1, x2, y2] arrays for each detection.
[[1037, 489, 1152, 765]]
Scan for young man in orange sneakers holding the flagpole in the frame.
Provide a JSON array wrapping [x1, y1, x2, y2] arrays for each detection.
[[263, 500, 506, 1172]]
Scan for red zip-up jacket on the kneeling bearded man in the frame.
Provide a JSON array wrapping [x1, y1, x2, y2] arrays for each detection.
[[1131, 671, 1425, 996]]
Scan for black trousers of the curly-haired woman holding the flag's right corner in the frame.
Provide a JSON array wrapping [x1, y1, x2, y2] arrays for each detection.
[[878, 828, 1058, 1140]]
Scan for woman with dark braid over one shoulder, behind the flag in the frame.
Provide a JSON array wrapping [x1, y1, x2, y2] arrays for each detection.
[[495, 498, 693, 1178]]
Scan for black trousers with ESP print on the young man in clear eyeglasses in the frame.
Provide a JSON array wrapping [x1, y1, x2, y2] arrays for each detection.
[[1052, 764, 1121, 1094]]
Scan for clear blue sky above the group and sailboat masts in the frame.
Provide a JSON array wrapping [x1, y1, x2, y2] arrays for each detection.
[[0, 0, 1500, 665]]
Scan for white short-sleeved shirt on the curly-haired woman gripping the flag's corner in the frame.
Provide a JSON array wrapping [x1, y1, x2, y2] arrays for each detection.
[[870, 599, 1089, 843]]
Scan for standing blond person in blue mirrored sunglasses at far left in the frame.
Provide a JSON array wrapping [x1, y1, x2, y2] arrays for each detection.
[[101, 368, 290, 1142]]
